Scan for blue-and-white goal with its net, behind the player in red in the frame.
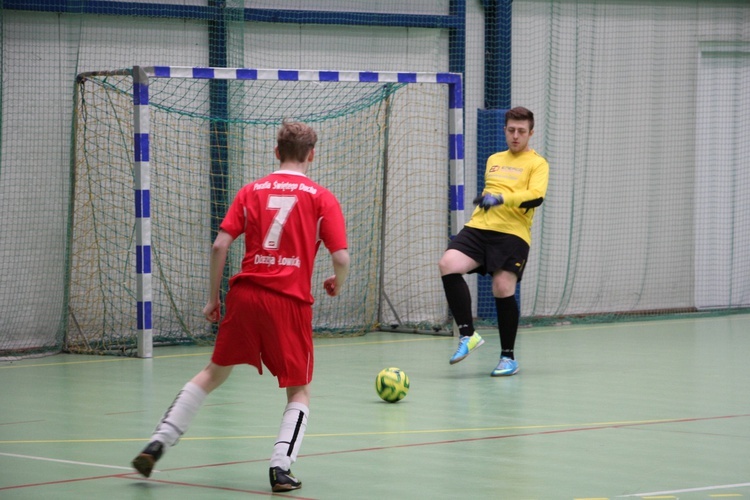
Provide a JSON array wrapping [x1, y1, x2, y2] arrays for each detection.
[[65, 67, 463, 357]]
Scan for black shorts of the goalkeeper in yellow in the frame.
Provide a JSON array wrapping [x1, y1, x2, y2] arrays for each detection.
[[448, 226, 529, 282]]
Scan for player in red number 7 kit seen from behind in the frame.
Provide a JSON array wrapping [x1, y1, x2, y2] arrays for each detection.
[[132, 121, 349, 491]]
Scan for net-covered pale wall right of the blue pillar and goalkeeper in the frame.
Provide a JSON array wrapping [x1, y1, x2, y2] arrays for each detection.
[[478, 0, 750, 325]]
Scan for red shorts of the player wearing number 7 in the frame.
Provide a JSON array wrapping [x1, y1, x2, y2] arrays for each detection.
[[211, 279, 314, 387]]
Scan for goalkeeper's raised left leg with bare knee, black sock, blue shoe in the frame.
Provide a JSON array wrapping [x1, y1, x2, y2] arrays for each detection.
[[438, 229, 484, 364]]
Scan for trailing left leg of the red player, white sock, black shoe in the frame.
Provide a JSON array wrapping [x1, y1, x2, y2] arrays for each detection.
[[132, 362, 232, 477]]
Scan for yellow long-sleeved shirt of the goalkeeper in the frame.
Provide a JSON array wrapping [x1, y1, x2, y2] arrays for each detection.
[[466, 149, 549, 245]]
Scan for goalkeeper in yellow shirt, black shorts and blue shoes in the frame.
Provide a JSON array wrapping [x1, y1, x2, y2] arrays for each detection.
[[439, 107, 549, 377]]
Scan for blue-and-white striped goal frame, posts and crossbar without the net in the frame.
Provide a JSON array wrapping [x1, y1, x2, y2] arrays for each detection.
[[132, 66, 464, 358]]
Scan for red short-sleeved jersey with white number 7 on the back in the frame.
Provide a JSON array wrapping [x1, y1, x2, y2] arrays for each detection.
[[221, 170, 347, 304]]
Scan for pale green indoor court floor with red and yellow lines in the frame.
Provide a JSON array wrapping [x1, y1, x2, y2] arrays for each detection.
[[0, 315, 750, 500]]
